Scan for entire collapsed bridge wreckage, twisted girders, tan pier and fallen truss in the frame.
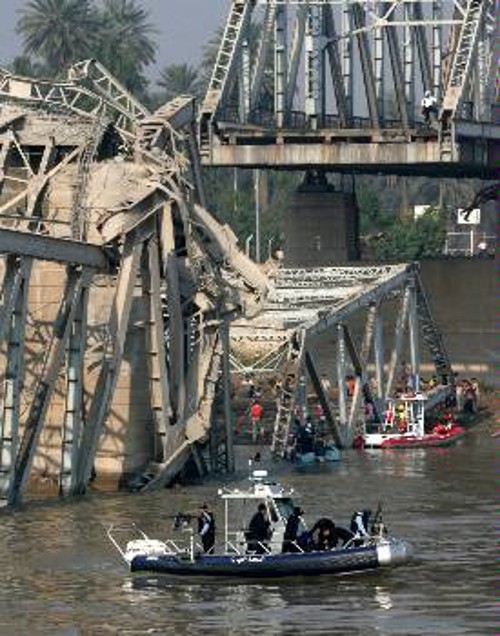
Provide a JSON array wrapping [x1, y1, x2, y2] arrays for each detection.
[[0, 60, 452, 504]]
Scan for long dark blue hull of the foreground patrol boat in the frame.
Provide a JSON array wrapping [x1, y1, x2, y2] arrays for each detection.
[[130, 541, 411, 578]]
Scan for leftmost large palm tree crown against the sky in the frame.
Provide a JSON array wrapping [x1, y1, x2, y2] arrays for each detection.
[[17, 0, 99, 75]]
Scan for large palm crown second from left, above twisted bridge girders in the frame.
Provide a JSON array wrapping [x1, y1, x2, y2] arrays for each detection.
[[95, 0, 156, 93]]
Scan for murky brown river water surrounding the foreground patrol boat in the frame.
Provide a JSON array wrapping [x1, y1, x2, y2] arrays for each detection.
[[0, 424, 500, 636]]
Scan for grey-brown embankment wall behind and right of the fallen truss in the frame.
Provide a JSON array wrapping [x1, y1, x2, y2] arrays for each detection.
[[304, 259, 500, 386]]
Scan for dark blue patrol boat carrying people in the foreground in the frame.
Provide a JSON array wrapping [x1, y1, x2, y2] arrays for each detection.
[[108, 470, 412, 578]]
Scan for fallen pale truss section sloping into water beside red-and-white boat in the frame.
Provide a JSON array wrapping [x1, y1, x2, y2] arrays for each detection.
[[231, 264, 454, 455]]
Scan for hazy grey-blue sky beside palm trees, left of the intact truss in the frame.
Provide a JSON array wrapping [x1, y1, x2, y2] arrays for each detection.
[[0, 0, 231, 74]]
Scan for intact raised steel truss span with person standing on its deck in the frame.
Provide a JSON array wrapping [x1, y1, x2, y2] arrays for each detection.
[[200, 0, 500, 178]]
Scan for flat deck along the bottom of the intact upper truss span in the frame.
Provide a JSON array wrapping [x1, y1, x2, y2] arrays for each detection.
[[202, 122, 500, 179]]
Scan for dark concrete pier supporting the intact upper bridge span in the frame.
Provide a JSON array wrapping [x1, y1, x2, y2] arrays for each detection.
[[284, 170, 360, 267]]
